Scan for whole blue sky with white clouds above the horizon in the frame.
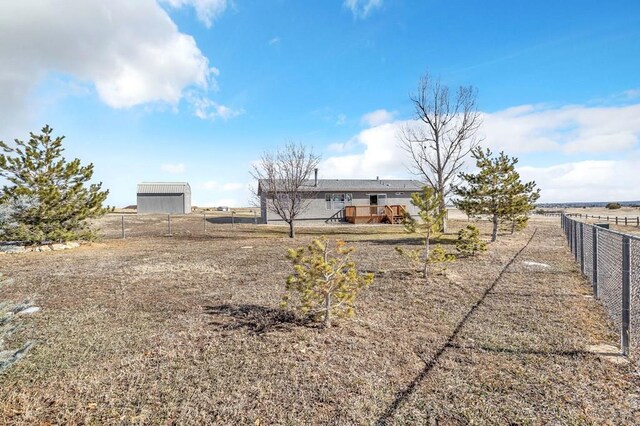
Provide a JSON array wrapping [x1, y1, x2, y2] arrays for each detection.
[[0, 0, 640, 206]]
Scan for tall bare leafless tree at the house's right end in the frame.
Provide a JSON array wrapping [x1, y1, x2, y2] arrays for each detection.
[[400, 74, 481, 232]]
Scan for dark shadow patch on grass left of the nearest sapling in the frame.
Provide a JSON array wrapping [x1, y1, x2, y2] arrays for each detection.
[[204, 304, 312, 334]]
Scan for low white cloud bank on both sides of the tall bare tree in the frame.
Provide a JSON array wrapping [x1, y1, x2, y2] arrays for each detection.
[[320, 104, 640, 202]]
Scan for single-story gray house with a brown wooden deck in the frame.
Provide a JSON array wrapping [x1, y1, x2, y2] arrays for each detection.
[[258, 175, 424, 224]]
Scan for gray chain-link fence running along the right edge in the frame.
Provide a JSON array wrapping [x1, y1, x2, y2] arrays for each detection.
[[561, 215, 640, 359]]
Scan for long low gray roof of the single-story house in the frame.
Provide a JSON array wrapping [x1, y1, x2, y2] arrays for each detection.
[[260, 179, 424, 192]]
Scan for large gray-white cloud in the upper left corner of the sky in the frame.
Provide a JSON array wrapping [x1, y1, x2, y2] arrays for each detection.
[[0, 0, 232, 128]]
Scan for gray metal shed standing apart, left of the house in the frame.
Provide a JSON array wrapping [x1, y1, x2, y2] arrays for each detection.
[[137, 182, 191, 214]]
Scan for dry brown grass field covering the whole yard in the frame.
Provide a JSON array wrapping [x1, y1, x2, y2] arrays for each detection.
[[0, 216, 640, 425]]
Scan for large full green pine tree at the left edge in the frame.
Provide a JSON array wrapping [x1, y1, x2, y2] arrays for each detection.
[[0, 125, 109, 243]]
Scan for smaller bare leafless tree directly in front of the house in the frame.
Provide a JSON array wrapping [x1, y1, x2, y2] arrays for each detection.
[[251, 143, 320, 238]]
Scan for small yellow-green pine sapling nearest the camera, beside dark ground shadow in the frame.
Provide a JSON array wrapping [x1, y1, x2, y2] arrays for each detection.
[[281, 238, 373, 328]]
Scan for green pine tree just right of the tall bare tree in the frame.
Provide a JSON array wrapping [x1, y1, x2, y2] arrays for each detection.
[[453, 147, 540, 241]]
